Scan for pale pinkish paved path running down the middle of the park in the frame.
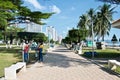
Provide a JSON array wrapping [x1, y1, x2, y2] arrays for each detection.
[[18, 46, 120, 80]]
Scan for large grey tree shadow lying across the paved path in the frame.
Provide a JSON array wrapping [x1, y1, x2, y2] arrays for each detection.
[[44, 49, 91, 68]]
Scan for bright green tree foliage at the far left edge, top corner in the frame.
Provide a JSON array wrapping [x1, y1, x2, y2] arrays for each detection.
[[0, 0, 17, 39]]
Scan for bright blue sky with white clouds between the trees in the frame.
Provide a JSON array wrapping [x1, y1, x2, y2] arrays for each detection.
[[23, 0, 120, 40]]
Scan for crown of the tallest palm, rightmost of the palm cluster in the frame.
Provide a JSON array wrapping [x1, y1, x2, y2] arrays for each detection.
[[95, 4, 115, 41]]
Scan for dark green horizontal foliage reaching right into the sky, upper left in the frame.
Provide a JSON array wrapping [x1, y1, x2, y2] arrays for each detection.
[[16, 6, 53, 25]]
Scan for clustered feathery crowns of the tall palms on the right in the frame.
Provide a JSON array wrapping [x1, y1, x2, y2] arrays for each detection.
[[77, 4, 115, 41]]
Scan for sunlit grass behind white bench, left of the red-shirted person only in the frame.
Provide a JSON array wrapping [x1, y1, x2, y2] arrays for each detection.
[[0, 48, 21, 77]]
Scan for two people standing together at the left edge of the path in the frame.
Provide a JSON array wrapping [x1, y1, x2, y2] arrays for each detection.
[[23, 41, 43, 62]]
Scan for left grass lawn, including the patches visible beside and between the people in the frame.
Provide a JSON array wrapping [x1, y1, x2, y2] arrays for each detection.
[[0, 46, 48, 77]]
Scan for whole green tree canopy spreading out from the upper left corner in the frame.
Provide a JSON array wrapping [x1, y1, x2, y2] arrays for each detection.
[[0, 0, 53, 30]]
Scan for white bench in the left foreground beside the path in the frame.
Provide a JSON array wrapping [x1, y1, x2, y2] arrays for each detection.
[[4, 62, 26, 80]]
